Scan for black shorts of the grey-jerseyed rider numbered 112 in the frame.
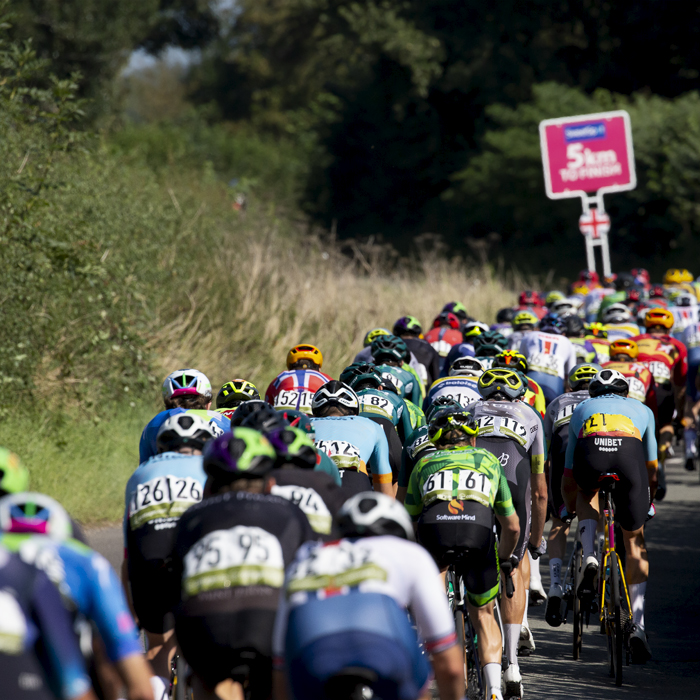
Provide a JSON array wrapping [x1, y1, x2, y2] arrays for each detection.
[[476, 437, 532, 559]]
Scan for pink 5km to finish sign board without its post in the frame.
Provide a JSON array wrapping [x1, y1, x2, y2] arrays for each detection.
[[540, 110, 637, 199]]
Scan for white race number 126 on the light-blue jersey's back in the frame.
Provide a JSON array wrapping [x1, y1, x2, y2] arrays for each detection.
[[129, 475, 202, 530]]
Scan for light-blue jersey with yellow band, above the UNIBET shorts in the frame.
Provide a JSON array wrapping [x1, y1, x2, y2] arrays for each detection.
[[564, 394, 656, 474]]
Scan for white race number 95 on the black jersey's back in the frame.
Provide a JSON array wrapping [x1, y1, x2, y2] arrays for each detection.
[[182, 525, 284, 597]]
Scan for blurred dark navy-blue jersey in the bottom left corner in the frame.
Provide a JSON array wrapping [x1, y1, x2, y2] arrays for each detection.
[[0, 548, 92, 700]]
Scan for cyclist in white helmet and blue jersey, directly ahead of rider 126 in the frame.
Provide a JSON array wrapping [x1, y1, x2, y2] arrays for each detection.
[[139, 369, 230, 464]]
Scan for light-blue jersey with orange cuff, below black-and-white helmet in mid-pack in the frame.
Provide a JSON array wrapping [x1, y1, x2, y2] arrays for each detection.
[[312, 416, 392, 484]]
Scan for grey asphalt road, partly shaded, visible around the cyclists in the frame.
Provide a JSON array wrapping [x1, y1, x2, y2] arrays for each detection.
[[87, 460, 700, 700]]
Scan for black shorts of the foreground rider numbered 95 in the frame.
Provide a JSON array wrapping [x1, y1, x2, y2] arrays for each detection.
[[175, 608, 275, 700]]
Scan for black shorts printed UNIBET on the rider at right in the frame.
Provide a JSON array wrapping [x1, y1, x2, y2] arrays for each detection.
[[573, 435, 650, 531]]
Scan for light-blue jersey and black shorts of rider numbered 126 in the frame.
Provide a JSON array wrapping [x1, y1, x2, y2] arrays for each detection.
[[123, 452, 207, 633]]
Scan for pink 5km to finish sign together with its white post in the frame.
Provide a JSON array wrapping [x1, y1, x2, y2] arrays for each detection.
[[540, 110, 637, 275]]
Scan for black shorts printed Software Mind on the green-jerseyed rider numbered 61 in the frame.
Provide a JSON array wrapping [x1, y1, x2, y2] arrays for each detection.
[[417, 501, 499, 607]]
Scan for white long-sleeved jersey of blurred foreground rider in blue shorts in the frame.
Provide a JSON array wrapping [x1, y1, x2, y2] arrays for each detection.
[[272, 536, 455, 659]]
